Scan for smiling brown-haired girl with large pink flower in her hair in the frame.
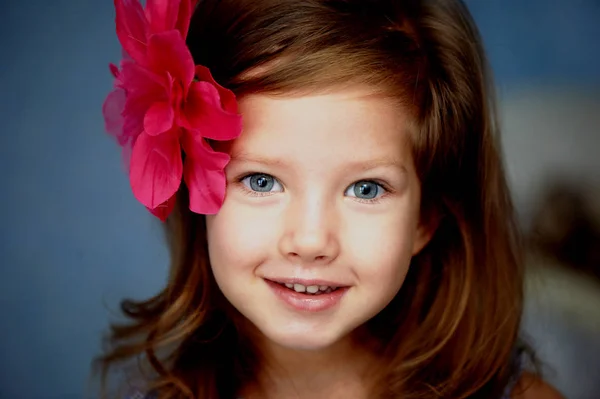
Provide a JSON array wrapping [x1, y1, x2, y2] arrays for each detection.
[[99, 0, 558, 399]]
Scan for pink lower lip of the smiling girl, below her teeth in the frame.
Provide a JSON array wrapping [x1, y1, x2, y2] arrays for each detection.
[[265, 280, 349, 312]]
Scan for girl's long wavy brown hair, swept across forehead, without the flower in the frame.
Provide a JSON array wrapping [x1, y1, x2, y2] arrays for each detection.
[[94, 0, 523, 399]]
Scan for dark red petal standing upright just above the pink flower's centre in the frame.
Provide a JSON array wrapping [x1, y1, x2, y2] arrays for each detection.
[[148, 30, 194, 86]]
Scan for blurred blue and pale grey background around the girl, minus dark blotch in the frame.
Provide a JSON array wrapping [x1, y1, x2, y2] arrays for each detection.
[[0, 0, 600, 399]]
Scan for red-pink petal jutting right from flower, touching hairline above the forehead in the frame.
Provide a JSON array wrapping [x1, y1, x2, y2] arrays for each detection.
[[184, 82, 242, 141]]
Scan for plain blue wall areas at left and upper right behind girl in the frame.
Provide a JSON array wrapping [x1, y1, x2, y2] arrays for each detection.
[[0, 0, 600, 399]]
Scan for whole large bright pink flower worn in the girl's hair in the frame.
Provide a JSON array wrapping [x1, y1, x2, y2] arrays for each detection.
[[103, 0, 242, 221]]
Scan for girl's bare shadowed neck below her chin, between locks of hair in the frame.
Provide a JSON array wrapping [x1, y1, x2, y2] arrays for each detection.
[[242, 328, 375, 399]]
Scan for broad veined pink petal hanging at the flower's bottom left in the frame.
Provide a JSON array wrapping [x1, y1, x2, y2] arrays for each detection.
[[129, 131, 183, 209]]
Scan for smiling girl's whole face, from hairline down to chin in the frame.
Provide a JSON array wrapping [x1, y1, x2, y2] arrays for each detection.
[[207, 91, 429, 349]]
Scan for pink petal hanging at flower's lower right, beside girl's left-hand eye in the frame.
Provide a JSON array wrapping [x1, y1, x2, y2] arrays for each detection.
[[182, 131, 229, 215]]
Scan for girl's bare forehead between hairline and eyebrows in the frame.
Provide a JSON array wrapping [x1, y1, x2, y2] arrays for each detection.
[[229, 90, 409, 167]]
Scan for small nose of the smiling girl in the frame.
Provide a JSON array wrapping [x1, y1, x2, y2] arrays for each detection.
[[279, 198, 340, 265]]
